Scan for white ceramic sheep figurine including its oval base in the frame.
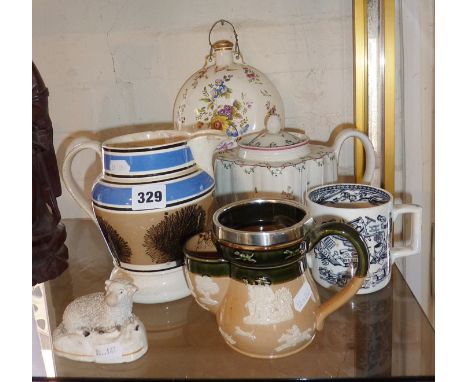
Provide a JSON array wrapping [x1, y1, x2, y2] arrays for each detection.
[[53, 277, 148, 363]]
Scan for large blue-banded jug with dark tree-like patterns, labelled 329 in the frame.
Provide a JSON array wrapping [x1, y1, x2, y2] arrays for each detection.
[[62, 130, 225, 303]]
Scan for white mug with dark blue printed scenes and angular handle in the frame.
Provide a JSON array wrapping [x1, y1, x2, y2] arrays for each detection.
[[307, 184, 422, 294]]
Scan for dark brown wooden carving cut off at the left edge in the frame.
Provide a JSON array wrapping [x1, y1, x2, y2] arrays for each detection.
[[32, 63, 68, 285]]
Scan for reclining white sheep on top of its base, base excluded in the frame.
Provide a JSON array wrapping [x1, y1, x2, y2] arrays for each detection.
[[63, 279, 138, 335]]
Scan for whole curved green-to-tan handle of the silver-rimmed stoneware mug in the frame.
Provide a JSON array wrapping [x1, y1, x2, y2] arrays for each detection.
[[309, 222, 369, 330]]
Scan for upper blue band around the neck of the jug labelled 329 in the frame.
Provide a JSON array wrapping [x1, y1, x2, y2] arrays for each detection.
[[104, 146, 193, 173]]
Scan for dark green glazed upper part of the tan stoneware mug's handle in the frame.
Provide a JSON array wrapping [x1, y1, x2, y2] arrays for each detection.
[[309, 222, 369, 277]]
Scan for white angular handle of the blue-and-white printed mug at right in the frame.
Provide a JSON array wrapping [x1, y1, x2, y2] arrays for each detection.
[[390, 204, 422, 264]]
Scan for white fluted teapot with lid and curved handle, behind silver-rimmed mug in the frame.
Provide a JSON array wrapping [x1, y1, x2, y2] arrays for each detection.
[[215, 114, 375, 204]]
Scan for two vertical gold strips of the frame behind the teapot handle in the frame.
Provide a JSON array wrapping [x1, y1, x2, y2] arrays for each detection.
[[353, 0, 395, 193]]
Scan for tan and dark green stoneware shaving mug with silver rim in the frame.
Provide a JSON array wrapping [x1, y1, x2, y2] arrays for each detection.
[[184, 199, 368, 358]]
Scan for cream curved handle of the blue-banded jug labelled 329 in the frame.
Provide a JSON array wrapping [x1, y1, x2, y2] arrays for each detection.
[[62, 141, 102, 223]]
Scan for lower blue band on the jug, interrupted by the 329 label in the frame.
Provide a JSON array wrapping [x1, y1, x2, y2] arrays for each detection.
[[93, 171, 214, 207]]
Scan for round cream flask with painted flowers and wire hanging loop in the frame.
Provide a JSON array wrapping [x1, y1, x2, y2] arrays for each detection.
[[173, 20, 284, 138]]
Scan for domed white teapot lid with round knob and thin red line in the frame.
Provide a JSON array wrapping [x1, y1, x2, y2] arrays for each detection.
[[237, 114, 310, 160]]
